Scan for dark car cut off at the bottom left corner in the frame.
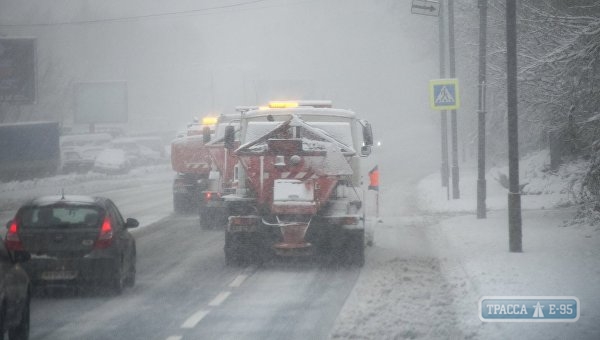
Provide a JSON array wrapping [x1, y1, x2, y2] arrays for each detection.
[[0, 242, 31, 340]]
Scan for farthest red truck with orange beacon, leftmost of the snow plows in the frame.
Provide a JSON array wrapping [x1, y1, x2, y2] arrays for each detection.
[[171, 117, 217, 213]]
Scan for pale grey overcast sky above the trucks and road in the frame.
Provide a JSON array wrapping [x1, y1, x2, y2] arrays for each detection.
[[0, 0, 439, 173]]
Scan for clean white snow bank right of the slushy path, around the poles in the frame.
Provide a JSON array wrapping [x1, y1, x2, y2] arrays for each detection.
[[419, 152, 600, 339]]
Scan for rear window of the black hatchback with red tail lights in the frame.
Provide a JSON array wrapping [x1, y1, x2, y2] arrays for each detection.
[[20, 205, 103, 228]]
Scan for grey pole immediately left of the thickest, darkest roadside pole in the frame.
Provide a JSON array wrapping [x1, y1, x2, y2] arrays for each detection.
[[477, 0, 487, 218]]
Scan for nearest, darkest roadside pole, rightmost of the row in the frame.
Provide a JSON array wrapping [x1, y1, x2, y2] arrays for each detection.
[[506, 0, 523, 253]]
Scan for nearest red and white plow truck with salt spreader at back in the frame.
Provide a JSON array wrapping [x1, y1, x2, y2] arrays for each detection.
[[224, 101, 373, 266]]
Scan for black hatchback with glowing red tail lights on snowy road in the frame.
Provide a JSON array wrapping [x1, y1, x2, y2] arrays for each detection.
[[5, 195, 139, 294]]
